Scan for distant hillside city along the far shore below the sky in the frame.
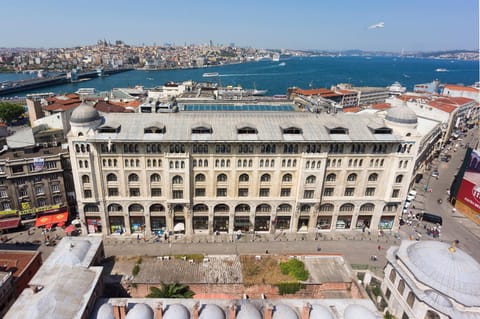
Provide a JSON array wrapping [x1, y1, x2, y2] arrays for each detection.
[[0, 40, 479, 72]]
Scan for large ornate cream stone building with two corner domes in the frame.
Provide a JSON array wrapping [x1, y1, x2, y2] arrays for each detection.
[[68, 104, 419, 236]]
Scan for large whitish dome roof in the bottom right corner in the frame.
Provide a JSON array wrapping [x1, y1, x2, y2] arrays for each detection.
[[402, 241, 480, 306]]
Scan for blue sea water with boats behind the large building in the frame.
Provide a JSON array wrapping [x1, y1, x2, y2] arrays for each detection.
[[0, 56, 479, 96]]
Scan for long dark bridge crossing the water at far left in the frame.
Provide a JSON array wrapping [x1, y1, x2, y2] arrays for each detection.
[[0, 68, 133, 96]]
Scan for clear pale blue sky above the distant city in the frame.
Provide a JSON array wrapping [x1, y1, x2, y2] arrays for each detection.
[[0, 0, 479, 52]]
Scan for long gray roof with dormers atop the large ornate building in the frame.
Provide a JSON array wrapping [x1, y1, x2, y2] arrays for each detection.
[[86, 112, 400, 142]]
